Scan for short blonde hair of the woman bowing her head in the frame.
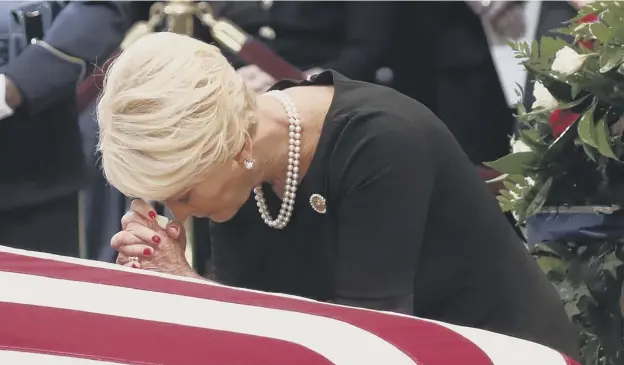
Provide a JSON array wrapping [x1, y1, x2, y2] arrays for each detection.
[[97, 32, 256, 200]]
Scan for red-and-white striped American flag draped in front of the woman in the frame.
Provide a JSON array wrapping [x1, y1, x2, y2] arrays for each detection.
[[0, 246, 576, 365]]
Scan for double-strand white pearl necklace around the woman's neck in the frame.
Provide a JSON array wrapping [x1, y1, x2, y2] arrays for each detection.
[[254, 90, 301, 229]]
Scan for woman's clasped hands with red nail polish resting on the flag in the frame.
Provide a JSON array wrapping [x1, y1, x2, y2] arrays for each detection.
[[111, 199, 194, 276]]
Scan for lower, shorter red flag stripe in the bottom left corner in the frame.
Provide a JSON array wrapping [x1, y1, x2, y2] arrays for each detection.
[[0, 300, 331, 365]]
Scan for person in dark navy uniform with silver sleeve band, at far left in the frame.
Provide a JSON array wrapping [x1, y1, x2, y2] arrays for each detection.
[[0, 1, 132, 256]]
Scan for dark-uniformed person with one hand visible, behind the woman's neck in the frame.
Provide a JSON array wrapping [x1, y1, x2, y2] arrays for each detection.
[[198, 0, 395, 92]]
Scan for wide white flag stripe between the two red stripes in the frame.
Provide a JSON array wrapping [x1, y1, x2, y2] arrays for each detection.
[[0, 272, 416, 365]]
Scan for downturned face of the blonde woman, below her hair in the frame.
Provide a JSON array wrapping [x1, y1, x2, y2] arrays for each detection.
[[165, 162, 254, 222]]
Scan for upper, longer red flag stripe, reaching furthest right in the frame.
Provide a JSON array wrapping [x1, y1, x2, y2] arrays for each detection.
[[0, 252, 493, 365]]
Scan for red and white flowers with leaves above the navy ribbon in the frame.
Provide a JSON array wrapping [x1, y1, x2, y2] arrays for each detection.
[[486, 2, 624, 220]]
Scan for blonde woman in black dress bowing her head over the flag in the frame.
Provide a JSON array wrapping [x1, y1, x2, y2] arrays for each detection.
[[98, 33, 576, 356]]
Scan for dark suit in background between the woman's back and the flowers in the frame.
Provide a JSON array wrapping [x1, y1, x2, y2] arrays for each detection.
[[392, 1, 514, 164]]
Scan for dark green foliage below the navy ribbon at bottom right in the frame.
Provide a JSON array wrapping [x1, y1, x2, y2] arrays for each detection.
[[531, 240, 624, 365]]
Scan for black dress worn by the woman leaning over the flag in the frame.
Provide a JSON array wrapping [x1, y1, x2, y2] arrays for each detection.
[[211, 71, 576, 356]]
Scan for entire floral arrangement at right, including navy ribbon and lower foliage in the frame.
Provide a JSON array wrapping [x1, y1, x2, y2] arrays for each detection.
[[486, 1, 624, 365]]
